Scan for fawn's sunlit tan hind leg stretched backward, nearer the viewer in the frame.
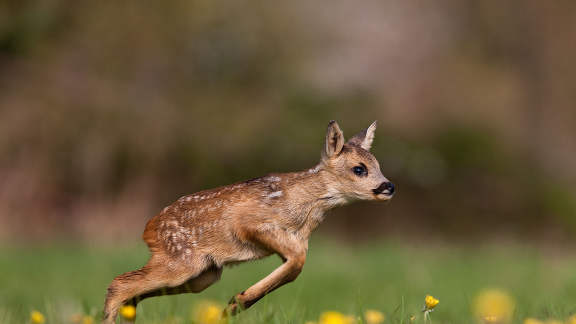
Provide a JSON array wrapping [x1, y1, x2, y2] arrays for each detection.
[[103, 258, 209, 324]]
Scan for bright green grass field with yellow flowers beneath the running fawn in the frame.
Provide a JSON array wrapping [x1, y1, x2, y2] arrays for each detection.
[[0, 240, 576, 324]]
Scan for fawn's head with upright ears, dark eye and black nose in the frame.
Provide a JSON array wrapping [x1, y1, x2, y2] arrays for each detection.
[[322, 121, 394, 200]]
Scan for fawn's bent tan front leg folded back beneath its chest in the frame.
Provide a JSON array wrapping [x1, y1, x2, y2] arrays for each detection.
[[225, 230, 308, 315]]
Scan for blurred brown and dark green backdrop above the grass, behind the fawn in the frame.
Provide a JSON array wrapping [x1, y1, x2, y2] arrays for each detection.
[[0, 0, 576, 244]]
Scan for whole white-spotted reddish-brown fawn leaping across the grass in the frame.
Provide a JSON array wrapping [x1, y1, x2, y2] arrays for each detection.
[[104, 121, 394, 324]]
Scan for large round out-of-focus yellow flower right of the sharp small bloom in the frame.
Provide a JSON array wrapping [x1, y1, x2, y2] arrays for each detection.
[[474, 289, 514, 323]]
